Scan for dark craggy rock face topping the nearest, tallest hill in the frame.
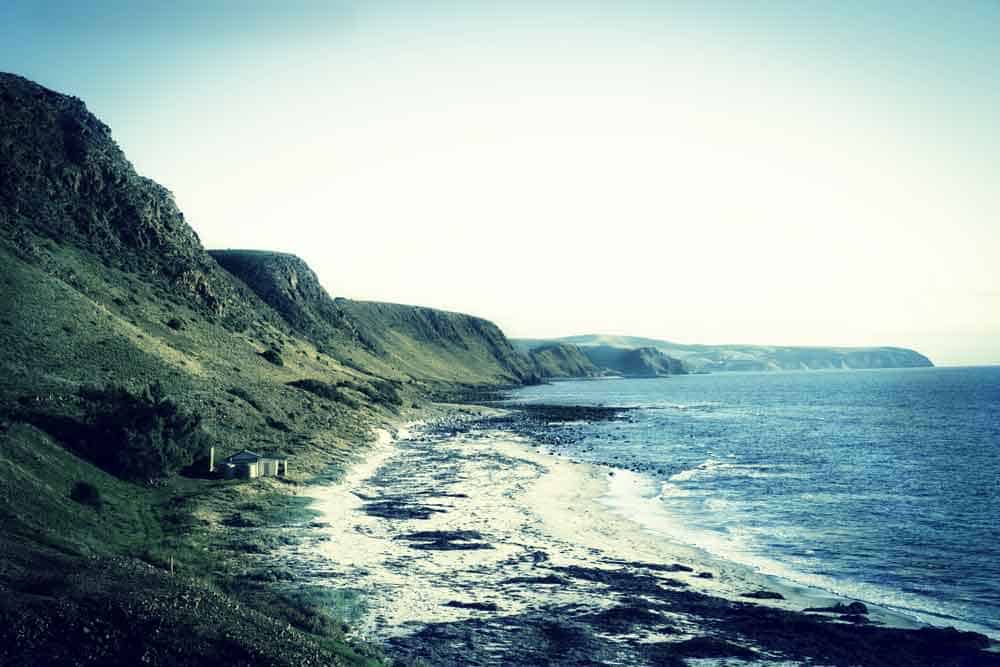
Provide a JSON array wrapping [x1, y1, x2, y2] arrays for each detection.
[[0, 73, 246, 315]]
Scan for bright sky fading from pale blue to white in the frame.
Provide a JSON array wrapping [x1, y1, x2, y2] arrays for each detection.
[[0, 0, 1000, 365]]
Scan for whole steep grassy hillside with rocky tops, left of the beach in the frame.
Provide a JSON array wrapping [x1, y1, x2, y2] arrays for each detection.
[[0, 74, 527, 665]]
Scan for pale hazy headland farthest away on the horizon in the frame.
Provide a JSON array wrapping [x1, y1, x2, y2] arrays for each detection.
[[514, 335, 934, 372]]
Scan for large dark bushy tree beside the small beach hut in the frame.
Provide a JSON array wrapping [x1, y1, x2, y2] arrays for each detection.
[[78, 383, 204, 480]]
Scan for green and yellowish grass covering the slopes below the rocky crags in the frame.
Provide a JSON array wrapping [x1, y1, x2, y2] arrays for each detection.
[[0, 243, 400, 664]]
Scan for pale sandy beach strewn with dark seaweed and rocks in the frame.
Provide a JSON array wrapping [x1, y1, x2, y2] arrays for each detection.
[[272, 408, 1000, 664]]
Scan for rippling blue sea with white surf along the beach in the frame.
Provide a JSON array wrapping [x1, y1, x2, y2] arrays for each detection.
[[512, 367, 1000, 638]]
